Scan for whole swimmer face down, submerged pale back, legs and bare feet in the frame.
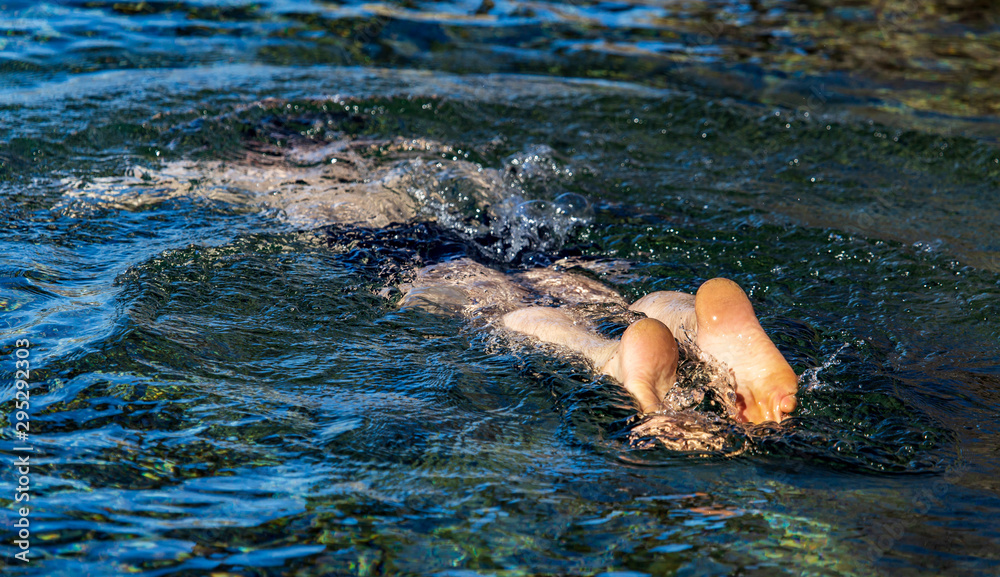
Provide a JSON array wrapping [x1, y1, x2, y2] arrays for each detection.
[[137, 134, 797, 422]]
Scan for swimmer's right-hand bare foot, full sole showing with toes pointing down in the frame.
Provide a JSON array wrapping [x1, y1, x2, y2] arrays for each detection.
[[695, 278, 798, 423]]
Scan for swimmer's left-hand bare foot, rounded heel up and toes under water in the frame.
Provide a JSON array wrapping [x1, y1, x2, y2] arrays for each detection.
[[603, 319, 677, 413]]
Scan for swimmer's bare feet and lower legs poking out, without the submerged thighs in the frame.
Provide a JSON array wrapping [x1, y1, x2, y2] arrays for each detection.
[[503, 278, 798, 423]]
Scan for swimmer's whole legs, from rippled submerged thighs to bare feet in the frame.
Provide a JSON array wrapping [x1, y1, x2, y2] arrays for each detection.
[[400, 258, 798, 423]]
